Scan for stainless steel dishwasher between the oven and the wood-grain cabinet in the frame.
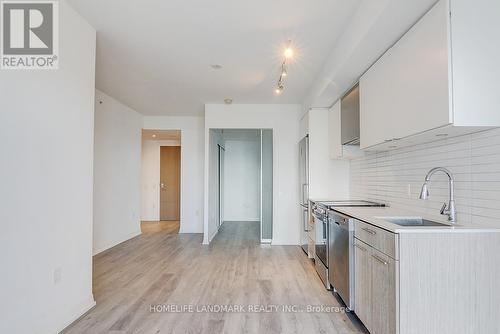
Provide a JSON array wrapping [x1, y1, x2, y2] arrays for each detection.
[[328, 210, 354, 310]]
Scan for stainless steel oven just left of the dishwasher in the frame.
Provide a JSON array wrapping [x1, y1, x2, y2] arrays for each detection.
[[312, 202, 331, 290]]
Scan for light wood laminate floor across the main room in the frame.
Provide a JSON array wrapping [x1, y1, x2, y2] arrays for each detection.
[[64, 223, 366, 334]]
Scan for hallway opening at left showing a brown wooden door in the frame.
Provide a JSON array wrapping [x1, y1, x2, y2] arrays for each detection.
[[141, 130, 182, 234]]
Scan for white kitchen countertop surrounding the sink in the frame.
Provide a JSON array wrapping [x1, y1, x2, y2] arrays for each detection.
[[328, 207, 500, 233]]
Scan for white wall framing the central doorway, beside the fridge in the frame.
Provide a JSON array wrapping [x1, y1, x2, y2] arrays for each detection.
[[204, 104, 300, 245]]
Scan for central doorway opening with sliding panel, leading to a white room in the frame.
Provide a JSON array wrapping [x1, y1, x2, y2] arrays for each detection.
[[208, 129, 273, 243]]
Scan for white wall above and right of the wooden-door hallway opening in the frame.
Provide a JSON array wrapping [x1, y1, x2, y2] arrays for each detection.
[[143, 116, 204, 233]]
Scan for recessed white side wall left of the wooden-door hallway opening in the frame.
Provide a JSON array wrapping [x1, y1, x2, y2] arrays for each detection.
[[94, 91, 142, 254]]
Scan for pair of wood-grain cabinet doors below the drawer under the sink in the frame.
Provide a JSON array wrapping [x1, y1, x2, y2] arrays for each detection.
[[354, 239, 398, 334]]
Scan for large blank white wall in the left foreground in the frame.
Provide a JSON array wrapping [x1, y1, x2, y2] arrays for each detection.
[[0, 1, 95, 334]]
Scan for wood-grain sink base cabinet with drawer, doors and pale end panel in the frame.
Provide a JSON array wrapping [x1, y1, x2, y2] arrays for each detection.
[[354, 218, 500, 334]]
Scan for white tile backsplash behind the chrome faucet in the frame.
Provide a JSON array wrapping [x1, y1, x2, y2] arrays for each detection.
[[350, 129, 500, 226]]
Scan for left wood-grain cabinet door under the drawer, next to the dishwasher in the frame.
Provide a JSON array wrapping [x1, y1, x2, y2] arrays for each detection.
[[354, 239, 372, 331]]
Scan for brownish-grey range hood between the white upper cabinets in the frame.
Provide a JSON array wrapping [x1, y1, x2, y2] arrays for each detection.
[[340, 85, 359, 145]]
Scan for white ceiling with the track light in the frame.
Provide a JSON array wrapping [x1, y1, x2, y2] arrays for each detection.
[[69, 0, 361, 115]]
